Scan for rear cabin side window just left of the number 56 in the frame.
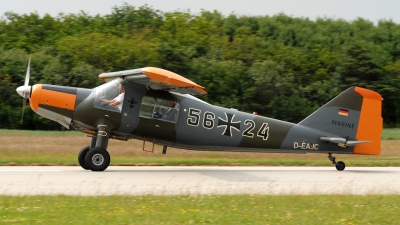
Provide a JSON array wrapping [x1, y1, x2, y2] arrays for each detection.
[[139, 96, 179, 123]]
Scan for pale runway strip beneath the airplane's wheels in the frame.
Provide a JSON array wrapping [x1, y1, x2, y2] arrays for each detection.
[[0, 166, 400, 196]]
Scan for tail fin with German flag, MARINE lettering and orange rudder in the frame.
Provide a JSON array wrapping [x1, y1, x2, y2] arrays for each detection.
[[299, 87, 383, 155]]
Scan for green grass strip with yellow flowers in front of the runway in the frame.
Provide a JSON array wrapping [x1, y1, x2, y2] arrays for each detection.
[[0, 195, 400, 224]]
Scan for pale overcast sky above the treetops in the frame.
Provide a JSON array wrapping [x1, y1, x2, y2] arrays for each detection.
[[0, 0, 400, 24]]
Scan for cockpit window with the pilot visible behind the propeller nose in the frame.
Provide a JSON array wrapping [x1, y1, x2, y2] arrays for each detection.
[[94, 80, 125, 112]]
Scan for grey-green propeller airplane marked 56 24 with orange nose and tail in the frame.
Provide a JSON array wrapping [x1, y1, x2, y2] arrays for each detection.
[[16, 59, 383, 171]]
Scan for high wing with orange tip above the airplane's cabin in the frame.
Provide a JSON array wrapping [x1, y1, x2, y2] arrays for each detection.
[[99, 67, 207, 95]]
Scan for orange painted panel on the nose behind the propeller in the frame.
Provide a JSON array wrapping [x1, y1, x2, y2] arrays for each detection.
[[39, 89, 76, 110]]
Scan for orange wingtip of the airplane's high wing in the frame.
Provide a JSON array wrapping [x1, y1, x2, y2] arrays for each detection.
[[142, 67, 207, 94]]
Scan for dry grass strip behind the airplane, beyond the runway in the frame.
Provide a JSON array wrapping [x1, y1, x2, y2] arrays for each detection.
[[0, 128, 400, 166]]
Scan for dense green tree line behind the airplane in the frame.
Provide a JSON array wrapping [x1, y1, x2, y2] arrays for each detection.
[[0, 3, 400, 130]]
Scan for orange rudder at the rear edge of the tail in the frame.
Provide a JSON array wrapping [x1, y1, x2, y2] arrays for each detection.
[[353, 87, 383, 155]]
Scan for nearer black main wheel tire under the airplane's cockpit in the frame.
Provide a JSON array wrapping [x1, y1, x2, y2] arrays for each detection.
[[85, 148, 111, 171]]
